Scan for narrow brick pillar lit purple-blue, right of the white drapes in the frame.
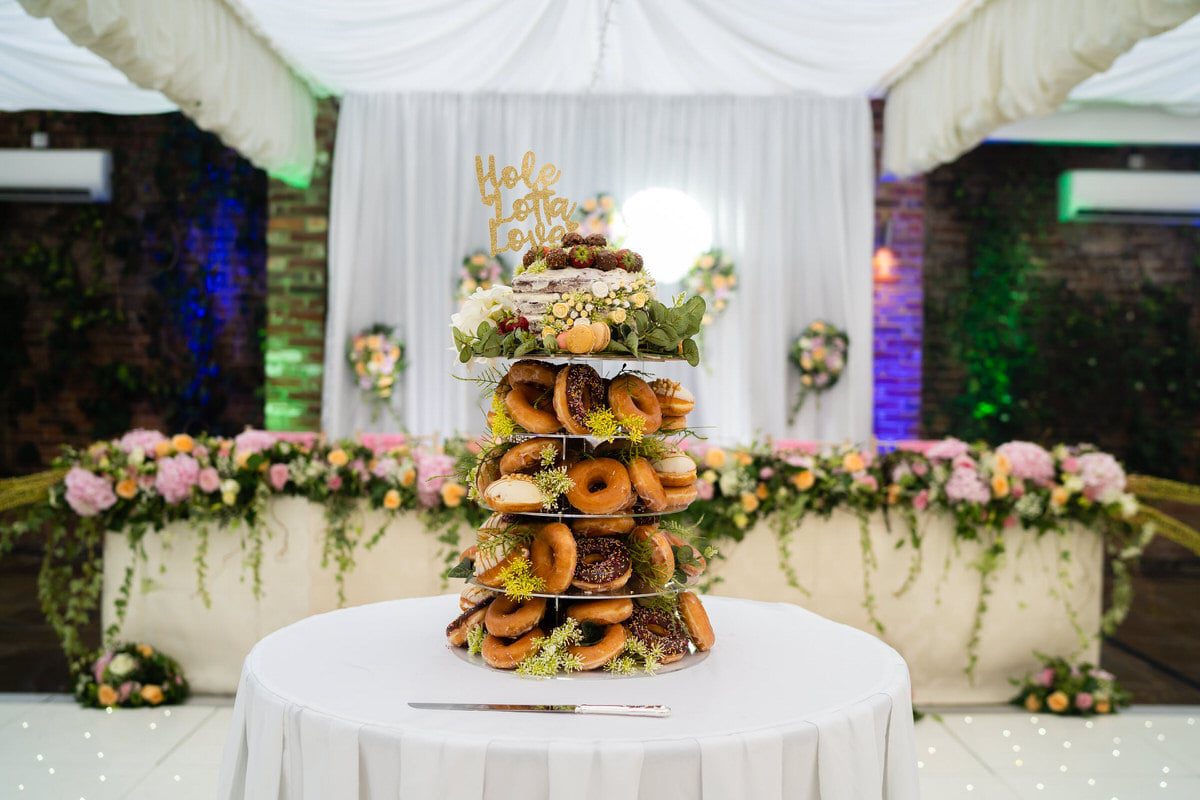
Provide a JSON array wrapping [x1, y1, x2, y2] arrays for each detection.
[[872, 101, 925, 439]]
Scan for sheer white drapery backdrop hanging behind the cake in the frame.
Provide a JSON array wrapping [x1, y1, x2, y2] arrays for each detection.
[[323, 94, 874, 441]]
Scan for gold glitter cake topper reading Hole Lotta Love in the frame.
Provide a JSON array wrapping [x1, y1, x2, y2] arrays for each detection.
[[475, 150, 580, 255]]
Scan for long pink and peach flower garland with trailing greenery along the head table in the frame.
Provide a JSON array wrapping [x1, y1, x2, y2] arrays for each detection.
[[0, 431, 1160, 675]]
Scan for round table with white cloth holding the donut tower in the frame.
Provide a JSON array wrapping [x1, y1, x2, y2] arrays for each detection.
[[220, 595, 918, 800]]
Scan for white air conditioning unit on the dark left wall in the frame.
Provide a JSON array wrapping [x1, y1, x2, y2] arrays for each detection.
[[0, 149, 113, 203]]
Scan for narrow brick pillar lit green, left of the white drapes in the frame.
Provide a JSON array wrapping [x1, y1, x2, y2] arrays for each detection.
[[265, 100, 337, 431]]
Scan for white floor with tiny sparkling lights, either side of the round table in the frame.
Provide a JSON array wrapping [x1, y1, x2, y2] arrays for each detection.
[[0, 694, 1200, 800]]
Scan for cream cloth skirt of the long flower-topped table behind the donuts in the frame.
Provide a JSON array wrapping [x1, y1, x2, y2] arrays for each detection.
[[104, 498, 1104, 705]]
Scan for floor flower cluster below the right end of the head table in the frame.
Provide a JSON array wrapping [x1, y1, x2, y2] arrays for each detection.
[[1012, 652, 1130, 716]]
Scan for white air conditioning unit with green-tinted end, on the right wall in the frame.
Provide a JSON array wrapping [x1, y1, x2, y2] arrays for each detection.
[[1058, 169, 1200, 225]]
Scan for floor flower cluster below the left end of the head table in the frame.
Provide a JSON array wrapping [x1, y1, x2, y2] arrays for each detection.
[[76, 644, 188, 709]]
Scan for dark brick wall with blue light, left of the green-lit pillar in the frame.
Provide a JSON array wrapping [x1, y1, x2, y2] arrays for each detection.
[[0, 112, 266, 475]]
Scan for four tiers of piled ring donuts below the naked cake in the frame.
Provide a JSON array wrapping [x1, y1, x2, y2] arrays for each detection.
[[446, 235, 715, 676]]
